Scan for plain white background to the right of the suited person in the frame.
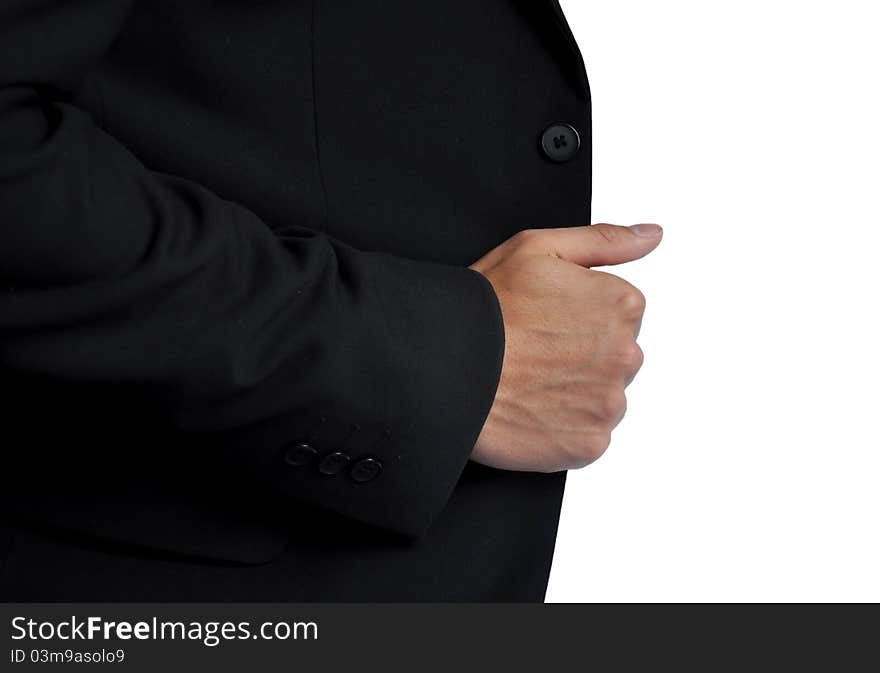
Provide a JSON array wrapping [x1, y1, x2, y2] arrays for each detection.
[[547, 0, 880, 602]]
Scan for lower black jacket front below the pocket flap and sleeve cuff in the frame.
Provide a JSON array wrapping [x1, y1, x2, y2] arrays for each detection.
[[0, 465, 565, 602]]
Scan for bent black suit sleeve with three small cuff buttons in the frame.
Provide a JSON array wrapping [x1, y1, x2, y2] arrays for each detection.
[[0, 0, 504, 535]]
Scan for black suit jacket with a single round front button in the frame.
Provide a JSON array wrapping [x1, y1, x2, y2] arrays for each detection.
[[0, 0, 591, 600]]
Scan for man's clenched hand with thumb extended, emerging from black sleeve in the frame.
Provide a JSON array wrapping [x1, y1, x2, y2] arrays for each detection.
[[471, 224, 662, 472]]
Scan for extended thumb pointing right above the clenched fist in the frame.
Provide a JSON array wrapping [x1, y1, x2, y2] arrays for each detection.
[[547, 224, 663, 267]]
